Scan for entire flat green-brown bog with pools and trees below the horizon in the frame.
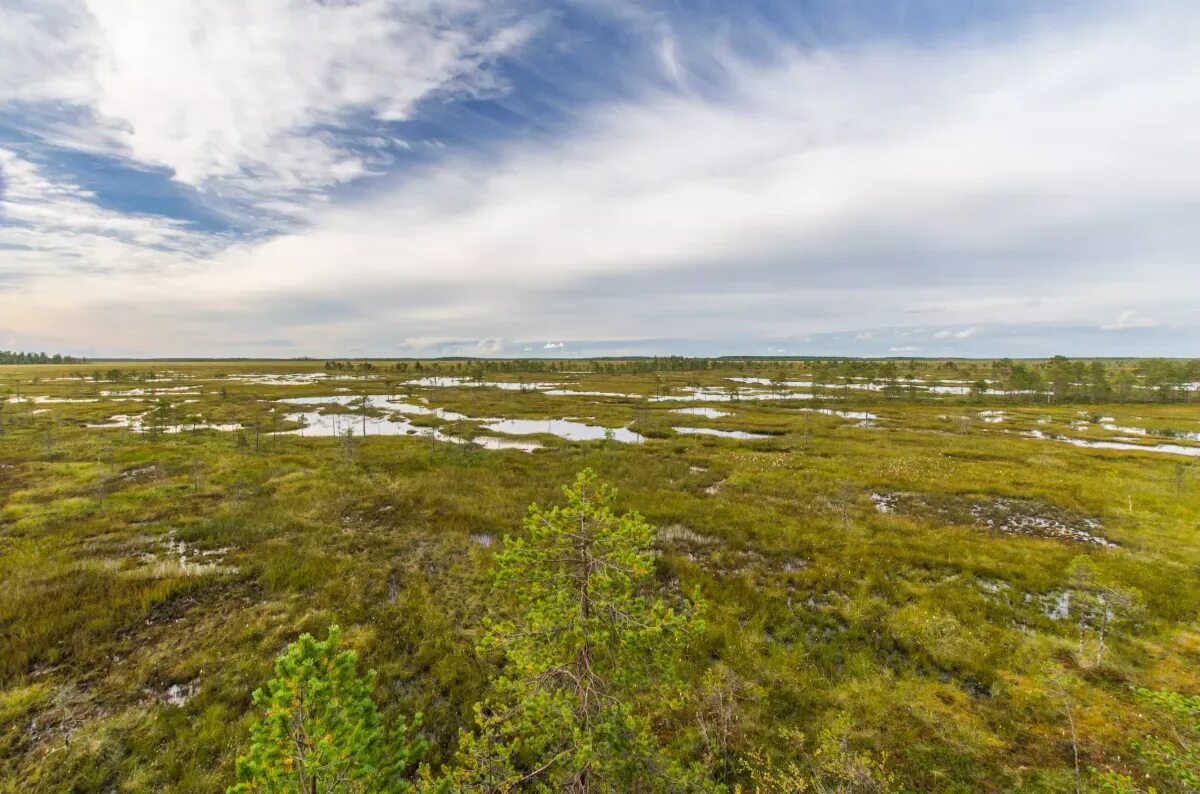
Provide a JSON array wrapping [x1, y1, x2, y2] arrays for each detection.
[[0, 357, 1200, 792]]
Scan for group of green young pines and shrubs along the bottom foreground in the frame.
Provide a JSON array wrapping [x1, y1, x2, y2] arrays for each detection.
[[229, 471, 892, 794]]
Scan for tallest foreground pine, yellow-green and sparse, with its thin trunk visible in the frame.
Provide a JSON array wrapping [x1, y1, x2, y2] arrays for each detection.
[[450, 470, 708, 793]]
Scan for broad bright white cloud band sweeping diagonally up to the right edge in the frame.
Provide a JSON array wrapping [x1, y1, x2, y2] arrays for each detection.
[[182, 1, 1200, 321]]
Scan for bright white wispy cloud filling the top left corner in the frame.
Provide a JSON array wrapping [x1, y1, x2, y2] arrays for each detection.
[[0, 0, 530, 211]]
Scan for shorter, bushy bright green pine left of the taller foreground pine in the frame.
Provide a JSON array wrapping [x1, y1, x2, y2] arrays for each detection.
[[229, 626, 425, 794]]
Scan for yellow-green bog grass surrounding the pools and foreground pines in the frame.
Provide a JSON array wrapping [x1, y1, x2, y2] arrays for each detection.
[[0, 362, 1200, 792]]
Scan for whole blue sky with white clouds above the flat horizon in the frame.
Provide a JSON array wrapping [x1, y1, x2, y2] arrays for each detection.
[[0, 0, 1200, 357]]
